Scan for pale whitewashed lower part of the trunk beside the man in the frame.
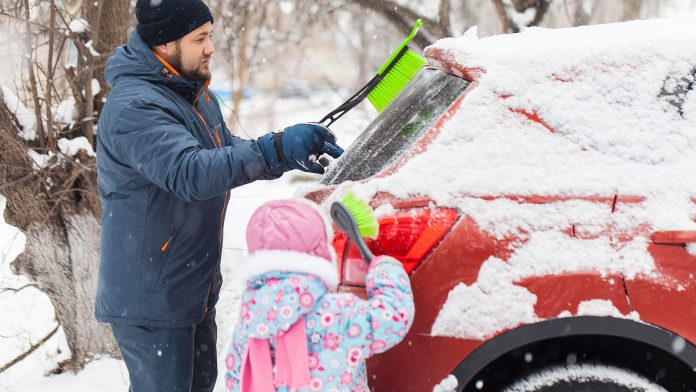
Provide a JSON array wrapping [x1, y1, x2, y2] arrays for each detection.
[[13, 207, 119, 370]]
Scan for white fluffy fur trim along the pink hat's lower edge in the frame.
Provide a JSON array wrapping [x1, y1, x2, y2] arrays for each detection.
[[237, 250, 338, 290]]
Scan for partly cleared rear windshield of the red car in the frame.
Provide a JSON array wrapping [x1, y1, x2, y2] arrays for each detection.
[[321, 69, 469, 185]]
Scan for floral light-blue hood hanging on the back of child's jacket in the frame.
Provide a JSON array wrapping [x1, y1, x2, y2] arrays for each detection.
[[237, 271, 327, 339]]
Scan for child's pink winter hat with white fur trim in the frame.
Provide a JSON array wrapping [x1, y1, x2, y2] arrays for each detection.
[[238, 199, 338, 289]]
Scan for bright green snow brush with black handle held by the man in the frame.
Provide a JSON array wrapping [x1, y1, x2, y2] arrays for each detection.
[[319, 19, 427, 127]]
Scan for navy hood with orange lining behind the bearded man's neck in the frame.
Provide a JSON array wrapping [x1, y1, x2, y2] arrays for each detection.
[[104, 31, 205, 100]]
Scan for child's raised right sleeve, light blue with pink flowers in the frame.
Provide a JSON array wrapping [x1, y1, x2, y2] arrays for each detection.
[[346, 256, 415, 357]]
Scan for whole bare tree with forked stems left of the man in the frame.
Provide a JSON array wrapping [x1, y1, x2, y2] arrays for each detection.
[[0, 0, 130, 370]]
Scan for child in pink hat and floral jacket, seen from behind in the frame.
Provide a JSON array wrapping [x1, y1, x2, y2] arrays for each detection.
[[225, 200, 414, 392]]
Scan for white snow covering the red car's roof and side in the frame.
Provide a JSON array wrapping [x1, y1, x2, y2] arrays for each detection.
[[339, 17, 696, 339]]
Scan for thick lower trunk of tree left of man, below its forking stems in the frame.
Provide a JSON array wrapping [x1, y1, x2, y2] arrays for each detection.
[[0, 95, 119, 370]]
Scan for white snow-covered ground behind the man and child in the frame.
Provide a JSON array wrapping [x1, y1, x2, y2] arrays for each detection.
[[0, 93, 374, 392]]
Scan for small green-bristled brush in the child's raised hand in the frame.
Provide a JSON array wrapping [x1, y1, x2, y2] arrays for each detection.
[[331, 192, 379, 264]]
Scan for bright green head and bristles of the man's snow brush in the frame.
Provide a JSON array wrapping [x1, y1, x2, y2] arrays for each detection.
[[367, 19, 427, 112]]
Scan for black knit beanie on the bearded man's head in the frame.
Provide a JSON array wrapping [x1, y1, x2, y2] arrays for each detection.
[[135, 0, 214, 46]]
